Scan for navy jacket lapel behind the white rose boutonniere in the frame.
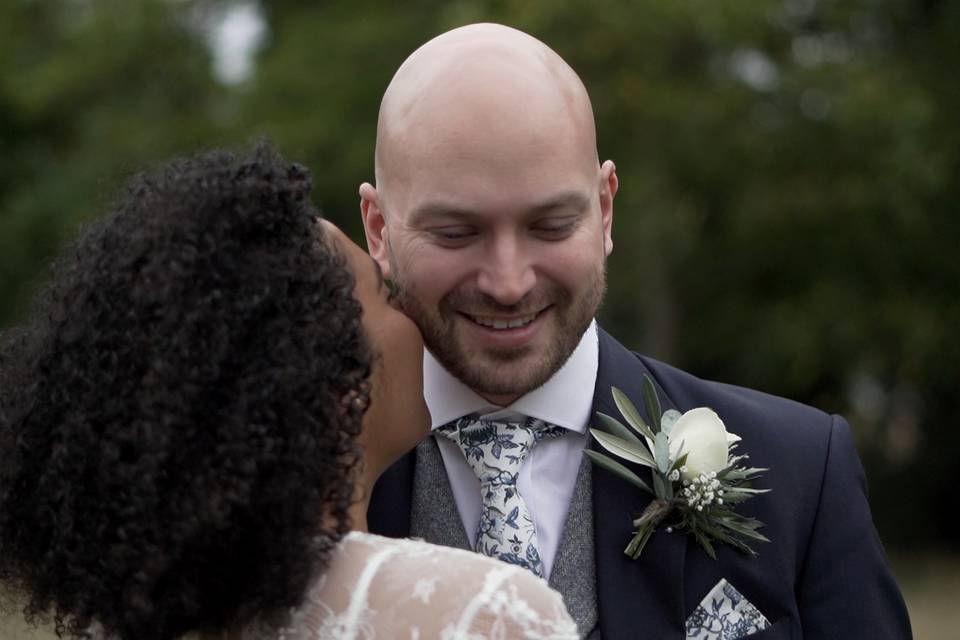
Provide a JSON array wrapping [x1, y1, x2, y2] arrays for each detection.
[[591, 330, 688, 638]]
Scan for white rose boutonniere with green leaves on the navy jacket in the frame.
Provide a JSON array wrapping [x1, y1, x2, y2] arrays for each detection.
[[584, 375, 769, 559]]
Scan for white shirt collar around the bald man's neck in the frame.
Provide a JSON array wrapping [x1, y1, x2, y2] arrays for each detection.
[[423, 320, 599, 433]]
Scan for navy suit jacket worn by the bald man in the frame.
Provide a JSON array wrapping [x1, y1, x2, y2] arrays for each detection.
[[369, 330, 911, 640]]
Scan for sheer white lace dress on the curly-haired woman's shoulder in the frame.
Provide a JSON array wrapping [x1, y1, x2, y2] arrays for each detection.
[[257, 532, 579, 640]]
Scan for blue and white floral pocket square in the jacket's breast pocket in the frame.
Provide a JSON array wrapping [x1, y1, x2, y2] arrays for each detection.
[[687, 579, 770, 640]]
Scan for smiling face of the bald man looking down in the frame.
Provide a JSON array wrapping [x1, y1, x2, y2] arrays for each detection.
[[364, 112, 616, 405]]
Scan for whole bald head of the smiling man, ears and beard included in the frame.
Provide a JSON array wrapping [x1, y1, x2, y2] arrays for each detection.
[[360, 24, 617, 404]]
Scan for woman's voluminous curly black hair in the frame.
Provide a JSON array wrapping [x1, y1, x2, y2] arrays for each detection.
[[0, 144, 373, 640]]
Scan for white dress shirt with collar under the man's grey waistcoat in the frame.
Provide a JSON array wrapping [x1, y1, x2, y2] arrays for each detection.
[[423, 321, 599, 577]]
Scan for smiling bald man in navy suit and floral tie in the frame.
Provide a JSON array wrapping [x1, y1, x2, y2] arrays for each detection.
[[360, 24, 910, 639]]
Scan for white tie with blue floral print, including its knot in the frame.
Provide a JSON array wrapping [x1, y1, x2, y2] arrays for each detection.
[[437, 415, 563, 576]]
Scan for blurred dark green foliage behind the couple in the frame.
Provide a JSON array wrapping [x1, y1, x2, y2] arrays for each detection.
[[0, 0, 960, 549]]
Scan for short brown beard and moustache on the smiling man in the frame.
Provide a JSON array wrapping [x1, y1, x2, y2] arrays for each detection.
[[392, 266, 606, 397]]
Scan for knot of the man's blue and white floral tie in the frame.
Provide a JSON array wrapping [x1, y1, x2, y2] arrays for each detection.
[[437, 415, 562, 483]]
